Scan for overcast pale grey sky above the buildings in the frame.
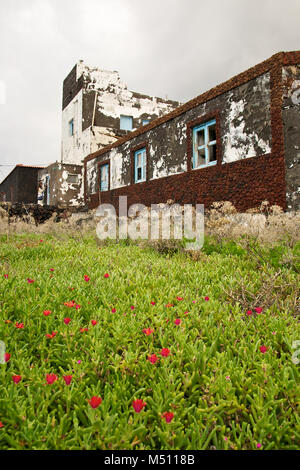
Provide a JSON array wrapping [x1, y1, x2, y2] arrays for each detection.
[[0, 0, 300, 181]]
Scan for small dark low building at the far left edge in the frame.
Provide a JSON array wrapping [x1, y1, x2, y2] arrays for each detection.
[[0, 164, 43, 204]]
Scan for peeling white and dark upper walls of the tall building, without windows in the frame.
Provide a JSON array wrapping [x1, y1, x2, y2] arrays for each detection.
[[61, 61, 179, 164]]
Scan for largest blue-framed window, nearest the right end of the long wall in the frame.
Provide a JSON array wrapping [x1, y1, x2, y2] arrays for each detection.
[[193, 119, 217, 168]]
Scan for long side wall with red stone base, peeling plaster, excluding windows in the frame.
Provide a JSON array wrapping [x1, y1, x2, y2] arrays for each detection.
[[86, 72, 284, 210]]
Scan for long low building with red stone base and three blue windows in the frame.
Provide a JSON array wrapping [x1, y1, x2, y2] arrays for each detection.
[[84, 51, 300, 211]]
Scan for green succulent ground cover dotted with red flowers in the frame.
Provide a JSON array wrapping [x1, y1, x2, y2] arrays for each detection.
[[0, 235, 300, 450]]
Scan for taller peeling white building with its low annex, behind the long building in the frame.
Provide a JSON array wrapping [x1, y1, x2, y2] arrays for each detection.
[[38, 61, 179, 207]]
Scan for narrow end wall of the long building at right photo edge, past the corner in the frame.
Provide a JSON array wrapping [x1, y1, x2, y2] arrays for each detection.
[[282, 64, 300, 210]]
